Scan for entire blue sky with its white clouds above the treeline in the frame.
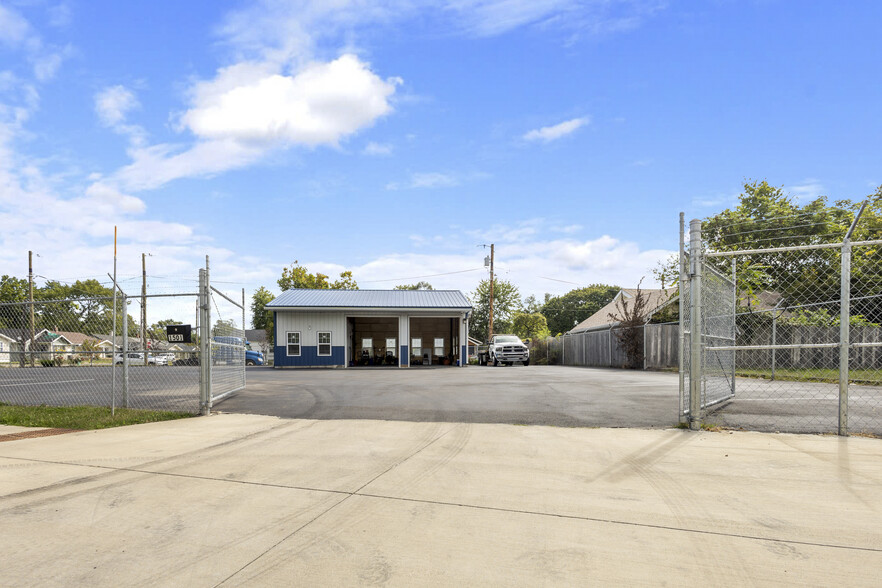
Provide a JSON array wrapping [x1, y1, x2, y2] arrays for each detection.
[[0, 0, 882, 326]]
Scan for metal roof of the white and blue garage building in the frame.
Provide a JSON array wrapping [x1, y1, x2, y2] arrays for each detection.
[[266, 290, 472, 310]]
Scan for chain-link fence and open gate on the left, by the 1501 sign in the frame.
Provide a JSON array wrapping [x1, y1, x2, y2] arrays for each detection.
[[0, 260, 245, 413]]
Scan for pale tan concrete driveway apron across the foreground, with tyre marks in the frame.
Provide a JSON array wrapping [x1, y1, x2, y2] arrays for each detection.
[[0, 414, 882, 587]]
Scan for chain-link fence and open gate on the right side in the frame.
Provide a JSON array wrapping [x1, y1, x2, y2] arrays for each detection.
[[681, 214, 882, 435]]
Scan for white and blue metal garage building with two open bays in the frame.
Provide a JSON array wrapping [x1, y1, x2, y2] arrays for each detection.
[[266, 289, 472, 367]]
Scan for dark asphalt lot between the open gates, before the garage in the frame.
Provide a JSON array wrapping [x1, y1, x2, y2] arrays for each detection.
[[215, 365, 679, 427]]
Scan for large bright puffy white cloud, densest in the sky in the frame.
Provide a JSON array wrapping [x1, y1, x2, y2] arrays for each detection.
[[181, 54, 398, 146]]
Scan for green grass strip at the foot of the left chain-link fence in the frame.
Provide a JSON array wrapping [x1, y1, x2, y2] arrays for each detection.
[[0, 403, 194, 431]]
